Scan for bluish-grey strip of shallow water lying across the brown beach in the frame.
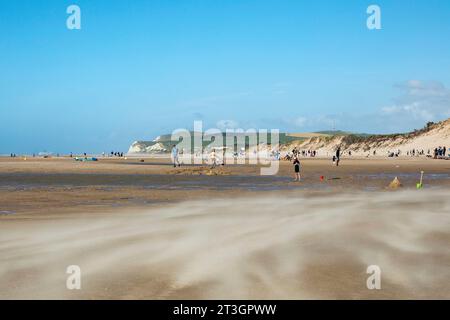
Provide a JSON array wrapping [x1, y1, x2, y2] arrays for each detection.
[[0, 173, 450, 191]]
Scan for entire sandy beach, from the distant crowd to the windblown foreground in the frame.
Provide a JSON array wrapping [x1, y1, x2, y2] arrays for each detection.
[[0, 158, 450, 299]]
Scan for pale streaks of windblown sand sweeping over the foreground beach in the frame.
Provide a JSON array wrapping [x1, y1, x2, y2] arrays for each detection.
[[0, 190, 450, 299]]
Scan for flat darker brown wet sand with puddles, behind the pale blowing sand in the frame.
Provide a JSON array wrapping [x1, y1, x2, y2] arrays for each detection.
[[0, 158, 450, 219]]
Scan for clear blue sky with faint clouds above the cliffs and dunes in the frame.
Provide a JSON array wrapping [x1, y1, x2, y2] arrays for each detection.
[[0, 0, 450, 153]]
